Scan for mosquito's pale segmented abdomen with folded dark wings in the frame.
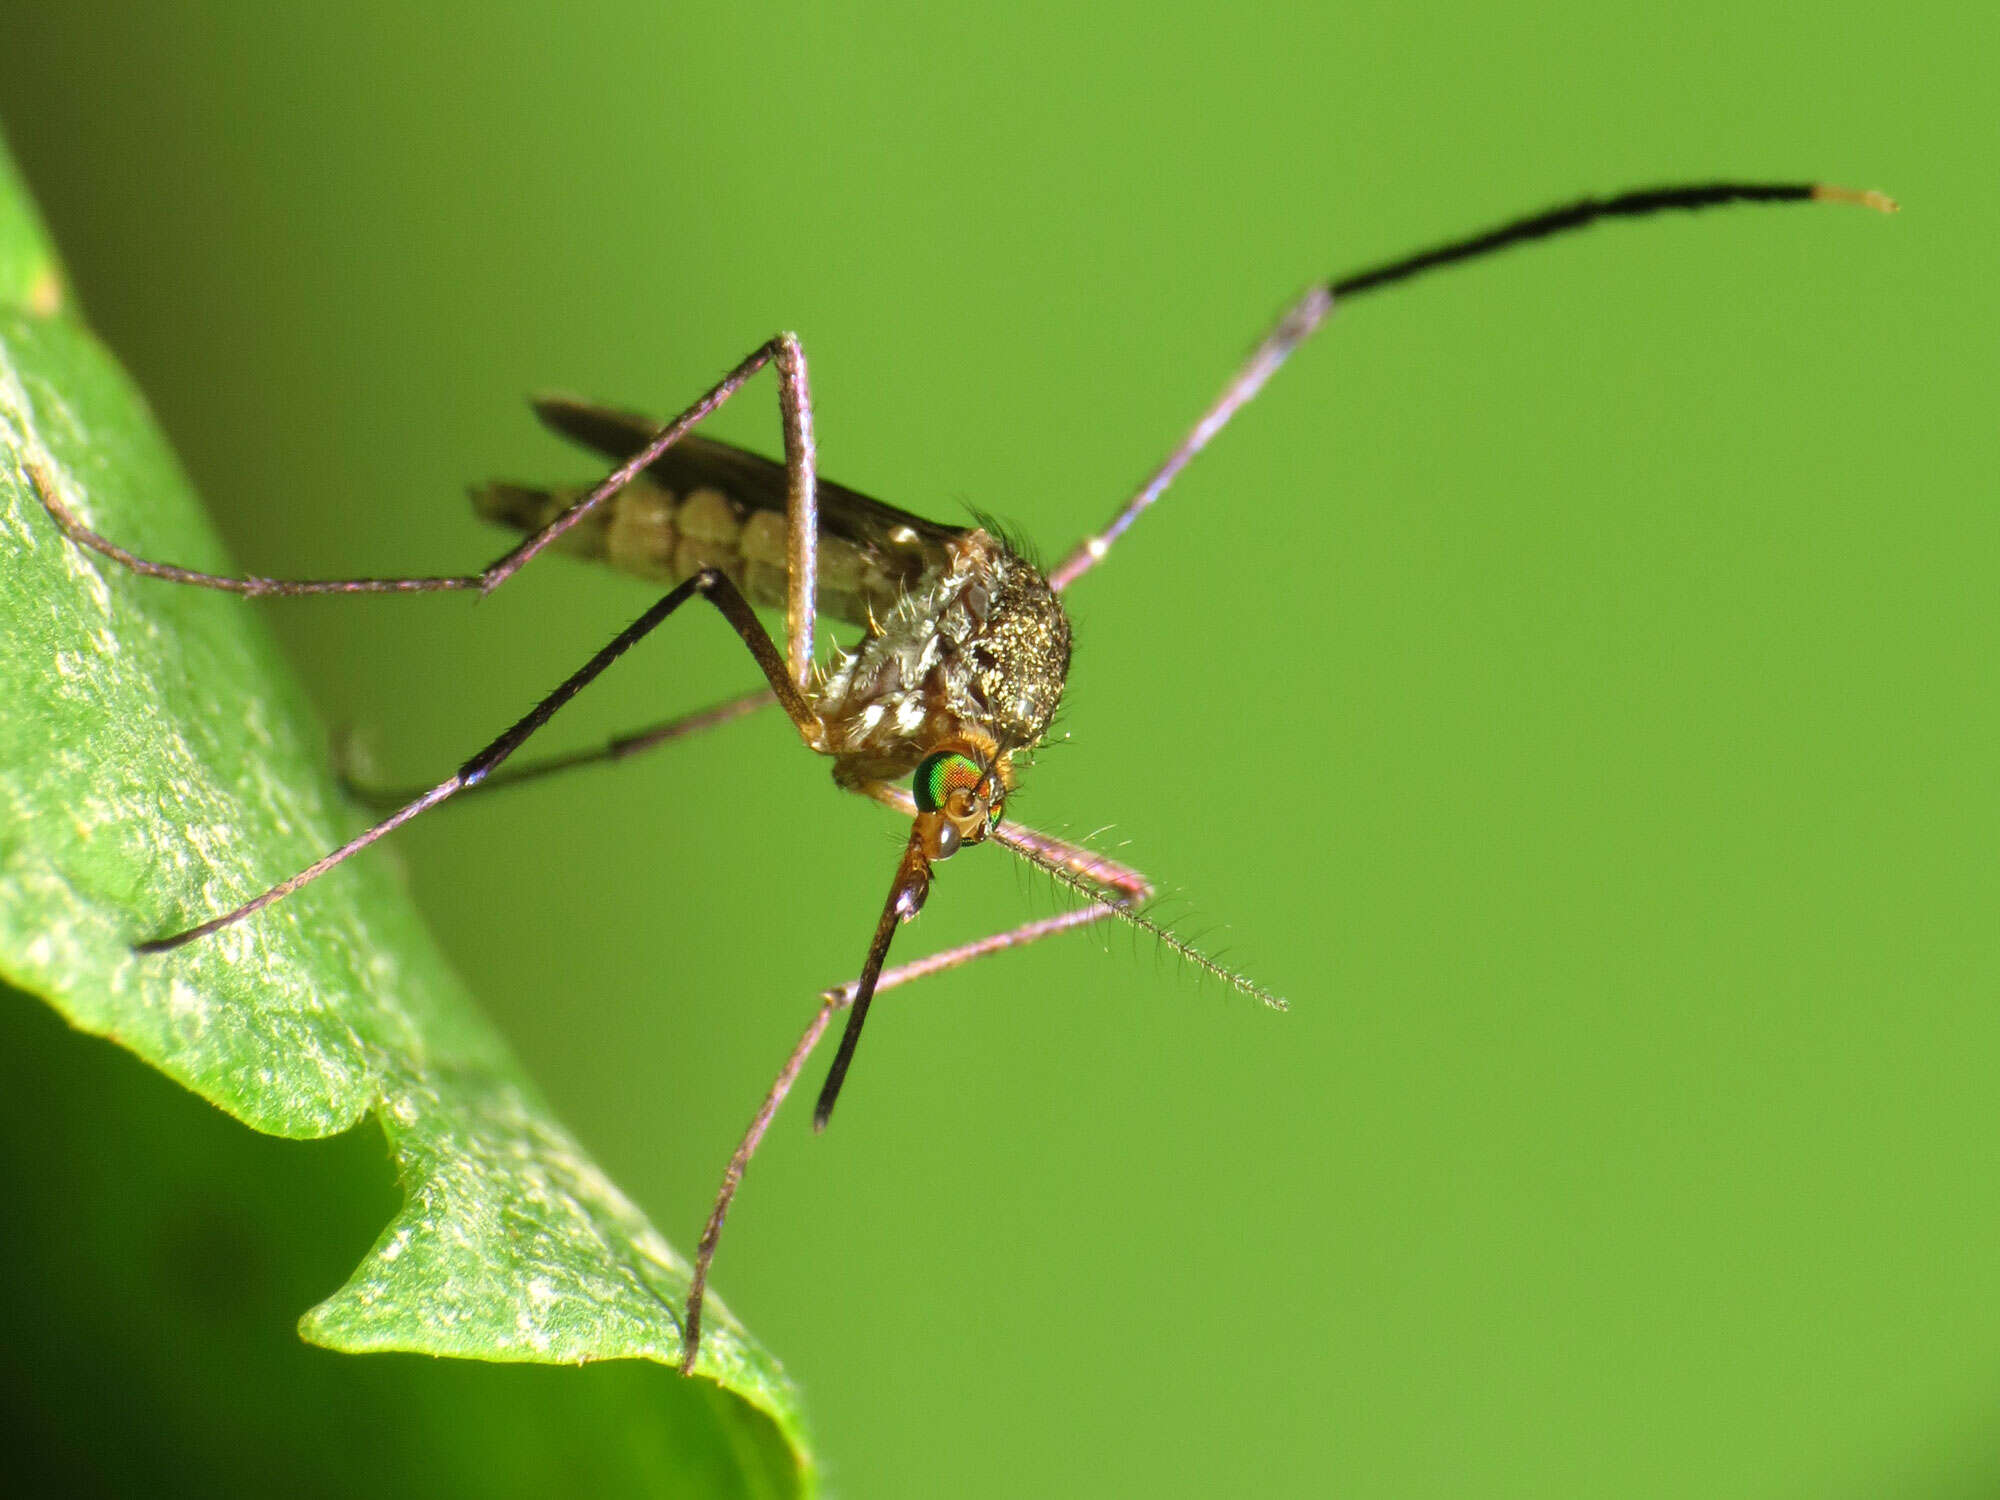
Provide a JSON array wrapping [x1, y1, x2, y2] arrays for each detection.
[[472, 396, 966, 624]]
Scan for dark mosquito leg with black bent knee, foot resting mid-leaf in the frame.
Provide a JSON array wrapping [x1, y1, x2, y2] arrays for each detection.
[[136, 568, 820, 954]]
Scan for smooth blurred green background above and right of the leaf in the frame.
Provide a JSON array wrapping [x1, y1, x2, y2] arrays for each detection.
[[0, 0, 2000, 1496]]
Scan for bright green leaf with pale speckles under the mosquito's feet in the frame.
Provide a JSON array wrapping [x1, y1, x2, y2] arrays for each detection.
[[0, 138, 812, 1492]]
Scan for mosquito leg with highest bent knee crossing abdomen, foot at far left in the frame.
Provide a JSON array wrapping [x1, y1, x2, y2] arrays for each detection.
[[24, 334, 818, 616]]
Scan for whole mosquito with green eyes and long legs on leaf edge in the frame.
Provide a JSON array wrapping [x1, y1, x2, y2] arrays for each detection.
[[28, 182, 1896, 1372]]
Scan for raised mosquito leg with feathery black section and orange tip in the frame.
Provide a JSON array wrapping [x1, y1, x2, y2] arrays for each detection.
[[1048, 182, 1896, 592]]
